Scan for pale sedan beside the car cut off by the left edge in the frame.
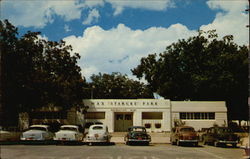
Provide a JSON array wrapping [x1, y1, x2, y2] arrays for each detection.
[[20, 125, 54, 141]]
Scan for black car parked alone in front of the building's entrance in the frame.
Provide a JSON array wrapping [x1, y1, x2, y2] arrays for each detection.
[[124, 126, 151, 145]]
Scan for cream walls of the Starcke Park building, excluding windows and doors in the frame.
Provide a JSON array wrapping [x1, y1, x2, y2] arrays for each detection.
[[84, 99, 227, 132]]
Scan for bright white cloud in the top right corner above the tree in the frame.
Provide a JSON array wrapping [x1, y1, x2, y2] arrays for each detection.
[[200, 0, 249, 45]]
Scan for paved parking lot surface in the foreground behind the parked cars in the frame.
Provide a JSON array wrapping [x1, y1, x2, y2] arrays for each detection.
[[0, 144, 243, 159]]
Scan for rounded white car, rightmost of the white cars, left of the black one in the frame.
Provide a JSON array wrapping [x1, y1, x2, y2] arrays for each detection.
[[85, 124, 111, 145]]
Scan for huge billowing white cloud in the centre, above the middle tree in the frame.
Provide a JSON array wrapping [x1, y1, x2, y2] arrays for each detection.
[[64, 24, 196, 79]]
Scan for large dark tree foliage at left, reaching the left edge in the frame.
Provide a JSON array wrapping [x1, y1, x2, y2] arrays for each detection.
[[0, 20, 85, 125]]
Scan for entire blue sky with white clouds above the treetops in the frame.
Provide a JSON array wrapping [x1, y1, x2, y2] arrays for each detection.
[[0, 0, 249, 80]]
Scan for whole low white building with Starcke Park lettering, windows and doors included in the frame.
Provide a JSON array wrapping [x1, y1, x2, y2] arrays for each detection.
[[84, 99, 227, 132]]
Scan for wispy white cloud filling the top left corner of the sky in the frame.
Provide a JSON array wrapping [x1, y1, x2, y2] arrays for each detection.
[[1, 0, 103, 28]]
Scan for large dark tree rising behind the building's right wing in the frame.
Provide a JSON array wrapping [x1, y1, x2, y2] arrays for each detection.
[[132, 30, 249, 119]]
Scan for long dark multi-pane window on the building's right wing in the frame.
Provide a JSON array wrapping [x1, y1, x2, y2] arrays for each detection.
[[180, 112, 215, 120]]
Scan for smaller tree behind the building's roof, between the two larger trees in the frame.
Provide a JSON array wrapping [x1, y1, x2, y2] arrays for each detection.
[[86, 72, 153, 99]]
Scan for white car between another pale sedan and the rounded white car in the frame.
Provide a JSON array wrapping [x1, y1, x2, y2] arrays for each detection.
[[54, 125, 83, 142]]
